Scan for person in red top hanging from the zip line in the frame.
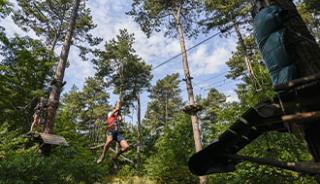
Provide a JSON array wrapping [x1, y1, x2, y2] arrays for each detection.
[[97, 102, 129, 164]]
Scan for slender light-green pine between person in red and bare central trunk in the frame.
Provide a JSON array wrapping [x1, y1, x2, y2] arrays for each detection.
[[142, 73, 183, 159]]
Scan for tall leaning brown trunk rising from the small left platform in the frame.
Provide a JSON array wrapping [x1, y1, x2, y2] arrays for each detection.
[[44, 0, 80, 133]]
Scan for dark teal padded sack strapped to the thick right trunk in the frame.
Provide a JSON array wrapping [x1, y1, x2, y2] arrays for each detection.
[[254, 5, 297, 85]]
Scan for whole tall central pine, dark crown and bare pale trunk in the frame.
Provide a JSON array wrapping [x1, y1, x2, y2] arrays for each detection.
[[128, 0, 206, 183]]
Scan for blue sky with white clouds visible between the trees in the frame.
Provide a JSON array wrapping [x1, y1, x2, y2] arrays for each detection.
[[1, 0, 237, 121]]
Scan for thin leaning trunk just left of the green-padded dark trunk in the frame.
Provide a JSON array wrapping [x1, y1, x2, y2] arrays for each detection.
[[233, 20, 261, 88]]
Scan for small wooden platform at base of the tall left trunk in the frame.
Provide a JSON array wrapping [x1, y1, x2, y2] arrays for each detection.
[[24, 132, 69, 146]]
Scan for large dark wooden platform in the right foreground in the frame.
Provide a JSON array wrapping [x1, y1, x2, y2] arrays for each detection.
[[189, 75, 320, 175]]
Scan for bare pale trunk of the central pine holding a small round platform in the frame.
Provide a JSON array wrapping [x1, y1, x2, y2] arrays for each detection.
[[175, 10, 207, 184]]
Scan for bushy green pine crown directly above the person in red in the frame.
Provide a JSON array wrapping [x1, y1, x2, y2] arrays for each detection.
[[94, 29, 152, 109]]
